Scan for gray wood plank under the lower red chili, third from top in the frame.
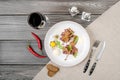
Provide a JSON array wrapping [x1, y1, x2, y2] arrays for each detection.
[[0, 40, 49, 64]]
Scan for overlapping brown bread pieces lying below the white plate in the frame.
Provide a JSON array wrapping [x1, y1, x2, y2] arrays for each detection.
[[47, 64, 59, 77]]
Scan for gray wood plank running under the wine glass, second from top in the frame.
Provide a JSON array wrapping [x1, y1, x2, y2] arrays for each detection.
[[0, 15, 99, 40]]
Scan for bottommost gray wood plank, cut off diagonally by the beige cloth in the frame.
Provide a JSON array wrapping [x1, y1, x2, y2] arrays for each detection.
[[0, 65, 45, 80]]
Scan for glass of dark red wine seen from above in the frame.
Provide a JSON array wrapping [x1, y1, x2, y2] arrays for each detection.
[[28, 12, 47, 29]]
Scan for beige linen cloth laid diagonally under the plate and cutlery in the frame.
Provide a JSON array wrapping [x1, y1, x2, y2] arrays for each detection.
[[33, 1, 120, 80]]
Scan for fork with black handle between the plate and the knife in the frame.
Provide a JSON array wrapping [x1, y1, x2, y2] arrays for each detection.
[[83, 40, 100, 73]]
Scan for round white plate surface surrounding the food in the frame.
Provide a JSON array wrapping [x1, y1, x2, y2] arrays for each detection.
[[44, 21, 90, 67]]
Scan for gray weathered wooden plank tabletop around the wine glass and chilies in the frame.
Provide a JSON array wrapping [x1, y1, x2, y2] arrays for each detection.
[[0, 0, 119, 80]]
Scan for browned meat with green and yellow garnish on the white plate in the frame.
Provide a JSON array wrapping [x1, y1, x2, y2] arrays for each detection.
[[50, 28, 79, 60]]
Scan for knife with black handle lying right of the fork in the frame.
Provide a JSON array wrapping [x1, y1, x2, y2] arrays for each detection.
[[89, 41, 106, 76]]
